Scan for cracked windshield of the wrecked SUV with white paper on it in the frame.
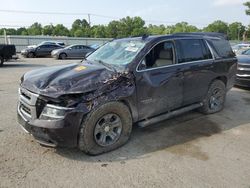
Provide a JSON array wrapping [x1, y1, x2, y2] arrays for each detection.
[[87, 40, 145, 65]]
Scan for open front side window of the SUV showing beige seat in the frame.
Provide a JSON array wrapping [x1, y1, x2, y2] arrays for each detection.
[[139, 41, 175, 70]]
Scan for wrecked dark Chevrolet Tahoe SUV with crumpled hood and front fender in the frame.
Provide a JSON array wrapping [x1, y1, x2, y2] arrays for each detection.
[[17, 33, 237, 155]]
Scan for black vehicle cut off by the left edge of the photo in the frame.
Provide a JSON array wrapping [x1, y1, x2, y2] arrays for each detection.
[[0, 44, 16, 67]]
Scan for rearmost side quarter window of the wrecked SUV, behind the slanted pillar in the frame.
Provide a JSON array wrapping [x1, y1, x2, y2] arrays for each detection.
[[208, 39, 235, 58]]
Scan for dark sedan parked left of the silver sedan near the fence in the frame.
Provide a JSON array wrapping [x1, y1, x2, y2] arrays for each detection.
[[21, 44, 63, 58]]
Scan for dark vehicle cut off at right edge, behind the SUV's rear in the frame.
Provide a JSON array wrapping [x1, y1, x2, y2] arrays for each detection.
[[235, 54, 250, 87]]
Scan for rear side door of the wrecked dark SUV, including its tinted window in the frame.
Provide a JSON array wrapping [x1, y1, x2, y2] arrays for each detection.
[[175, 39, 214, 105]]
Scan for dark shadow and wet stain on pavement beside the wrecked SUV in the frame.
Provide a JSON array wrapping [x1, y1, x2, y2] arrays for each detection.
[[56, 89, 250, 162]]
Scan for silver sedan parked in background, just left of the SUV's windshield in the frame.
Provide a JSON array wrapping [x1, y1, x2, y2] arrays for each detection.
[[51, 45, 94, 59]]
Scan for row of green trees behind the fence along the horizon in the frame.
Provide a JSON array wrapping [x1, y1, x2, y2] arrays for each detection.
[[0, 16, 250, 40]]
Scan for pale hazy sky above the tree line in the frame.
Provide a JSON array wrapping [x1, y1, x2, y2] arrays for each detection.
[[0, 0, 250, 28]]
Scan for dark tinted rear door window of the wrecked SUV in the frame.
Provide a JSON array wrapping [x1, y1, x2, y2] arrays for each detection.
[[176, 39, 212, 63]]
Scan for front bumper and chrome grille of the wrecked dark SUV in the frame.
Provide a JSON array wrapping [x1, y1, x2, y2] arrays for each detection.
[[17, 89, 83, 147]]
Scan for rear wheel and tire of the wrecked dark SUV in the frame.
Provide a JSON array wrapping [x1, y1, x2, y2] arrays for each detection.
[[200, 80, 226, 114]]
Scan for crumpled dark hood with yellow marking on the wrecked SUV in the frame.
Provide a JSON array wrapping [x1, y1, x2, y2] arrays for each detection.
[[21, 63, 117, 98]]
